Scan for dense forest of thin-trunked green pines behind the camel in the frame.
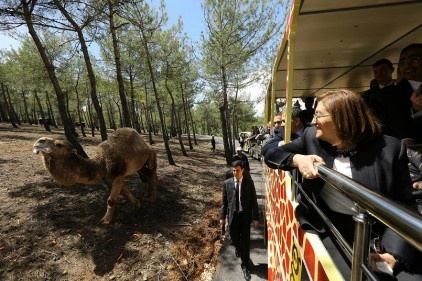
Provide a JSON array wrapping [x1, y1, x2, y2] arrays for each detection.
[[0, 0, 285, 164]]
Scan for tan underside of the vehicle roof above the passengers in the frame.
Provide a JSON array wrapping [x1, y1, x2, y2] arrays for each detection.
[[267, 0, 422, 100]]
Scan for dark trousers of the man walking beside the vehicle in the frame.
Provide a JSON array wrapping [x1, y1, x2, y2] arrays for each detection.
[[230, 213, 251, 269]]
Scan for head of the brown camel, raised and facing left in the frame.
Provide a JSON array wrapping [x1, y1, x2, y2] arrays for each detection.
[[33, 137, 76, 158]]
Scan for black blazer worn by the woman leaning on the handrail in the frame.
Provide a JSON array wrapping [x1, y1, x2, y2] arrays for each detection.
[[264, 127, 416, 260]]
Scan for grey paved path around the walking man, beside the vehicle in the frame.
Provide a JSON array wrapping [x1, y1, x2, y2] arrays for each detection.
[[213, 154, 268, 281]]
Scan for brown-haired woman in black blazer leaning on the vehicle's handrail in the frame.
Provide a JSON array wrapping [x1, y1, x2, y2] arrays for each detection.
[[265, 90, 420, 274]]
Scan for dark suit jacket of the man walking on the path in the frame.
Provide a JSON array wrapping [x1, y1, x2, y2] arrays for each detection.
[[220, 176, 259, 225]]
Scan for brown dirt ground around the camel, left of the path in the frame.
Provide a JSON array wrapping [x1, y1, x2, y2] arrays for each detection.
[[0, 123, 228, 281]]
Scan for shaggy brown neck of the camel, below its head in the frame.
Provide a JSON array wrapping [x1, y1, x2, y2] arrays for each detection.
[[44, 154, 105, 185]]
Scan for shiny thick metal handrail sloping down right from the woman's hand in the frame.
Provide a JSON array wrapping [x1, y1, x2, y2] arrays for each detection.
[[318, 165, 422, 251]]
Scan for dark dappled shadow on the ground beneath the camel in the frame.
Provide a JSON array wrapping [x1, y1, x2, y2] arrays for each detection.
[[5, 174, 199, 277]]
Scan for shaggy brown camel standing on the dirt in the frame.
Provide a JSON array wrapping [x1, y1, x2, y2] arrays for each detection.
[[34, 128, 157, 224]]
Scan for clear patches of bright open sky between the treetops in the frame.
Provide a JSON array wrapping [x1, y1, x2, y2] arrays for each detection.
[[0, 0, 264, 116]]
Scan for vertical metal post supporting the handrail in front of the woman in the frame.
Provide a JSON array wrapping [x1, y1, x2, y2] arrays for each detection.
[[350, 213, 370, 281]]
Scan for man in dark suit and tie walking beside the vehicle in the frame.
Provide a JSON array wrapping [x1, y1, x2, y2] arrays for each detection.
[[220, 160, 259, 280]]
